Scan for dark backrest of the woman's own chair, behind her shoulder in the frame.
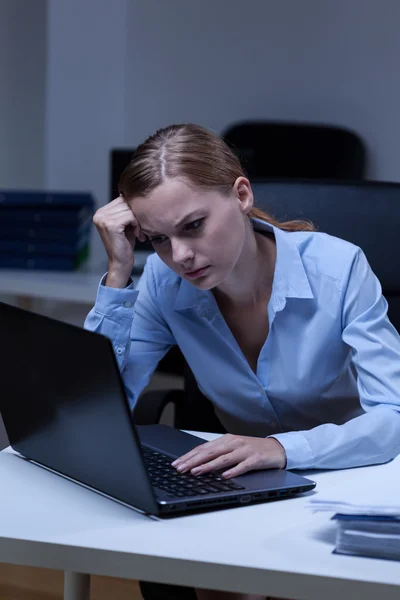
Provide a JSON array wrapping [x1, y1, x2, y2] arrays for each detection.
[[252, 180, 400, 331]]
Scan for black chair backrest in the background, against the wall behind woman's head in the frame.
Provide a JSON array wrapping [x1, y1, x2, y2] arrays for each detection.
[[222, 121, 366, 179]]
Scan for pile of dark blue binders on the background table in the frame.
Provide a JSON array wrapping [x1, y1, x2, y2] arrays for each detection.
[[0, 190, 94, 271]]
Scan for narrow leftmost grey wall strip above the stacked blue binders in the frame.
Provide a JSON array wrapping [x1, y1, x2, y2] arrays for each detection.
[[0, 0, 47, 188]]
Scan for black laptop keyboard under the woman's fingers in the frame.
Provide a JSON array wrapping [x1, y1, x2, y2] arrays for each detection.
[[142, 446, 245, 497]]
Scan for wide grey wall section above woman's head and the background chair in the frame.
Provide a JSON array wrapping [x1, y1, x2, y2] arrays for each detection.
[[126, 0, 400, 180]]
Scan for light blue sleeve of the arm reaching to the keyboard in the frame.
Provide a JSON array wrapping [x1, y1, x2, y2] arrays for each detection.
[[270, 249, 400, 469]]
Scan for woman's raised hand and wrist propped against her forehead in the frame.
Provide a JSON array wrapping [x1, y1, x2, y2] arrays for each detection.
[[93, 196, 146, 288]]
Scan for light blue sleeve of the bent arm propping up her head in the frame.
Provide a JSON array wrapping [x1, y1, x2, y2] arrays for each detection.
[[84, 262, 176, 408]]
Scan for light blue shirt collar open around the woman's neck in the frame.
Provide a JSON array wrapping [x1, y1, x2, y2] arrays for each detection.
[[174, 218, 314, 311]]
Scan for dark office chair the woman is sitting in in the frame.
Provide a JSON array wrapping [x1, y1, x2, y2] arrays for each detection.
[[133, 180, 400, 600]]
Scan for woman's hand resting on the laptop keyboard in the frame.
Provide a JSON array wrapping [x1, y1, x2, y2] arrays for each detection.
[[172, 434, 286, 479]]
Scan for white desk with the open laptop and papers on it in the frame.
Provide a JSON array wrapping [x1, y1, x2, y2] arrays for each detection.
[[0, 435, 400, 600]]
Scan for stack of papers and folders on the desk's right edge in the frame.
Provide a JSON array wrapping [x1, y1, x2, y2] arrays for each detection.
[[308, 458, 400, 560]]
